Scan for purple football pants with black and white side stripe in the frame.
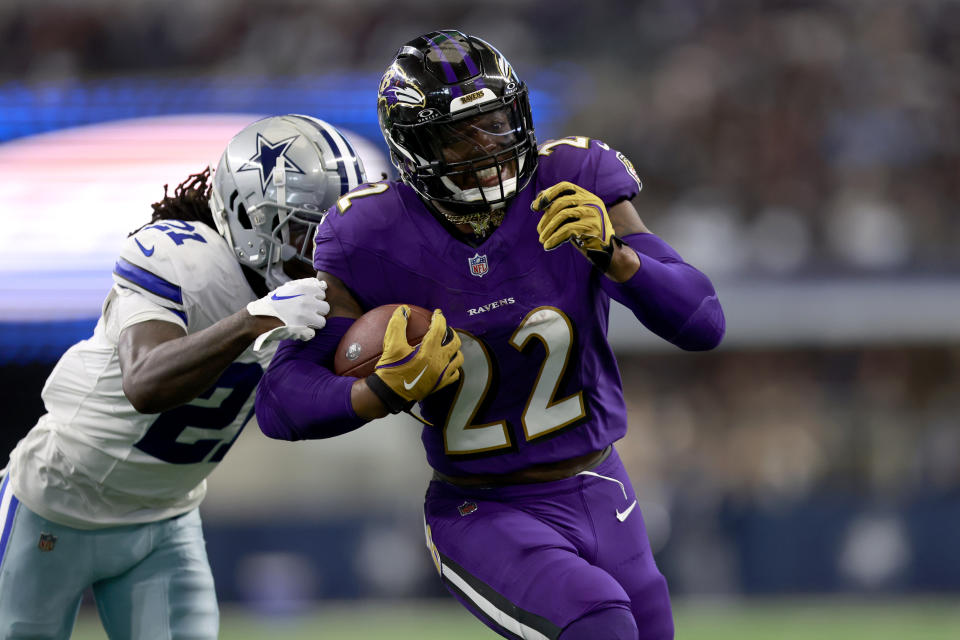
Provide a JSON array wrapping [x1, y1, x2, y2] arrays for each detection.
[[424, 450, 673, 640]]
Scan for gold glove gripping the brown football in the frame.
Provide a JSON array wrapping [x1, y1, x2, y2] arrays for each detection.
[[367, 305, 463, 413]]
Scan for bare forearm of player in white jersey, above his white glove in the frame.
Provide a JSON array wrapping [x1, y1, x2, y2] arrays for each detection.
[[123, 309, 280, 413]]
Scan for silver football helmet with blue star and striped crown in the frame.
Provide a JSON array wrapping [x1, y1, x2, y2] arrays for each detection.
[[210, 115, 366, 289]]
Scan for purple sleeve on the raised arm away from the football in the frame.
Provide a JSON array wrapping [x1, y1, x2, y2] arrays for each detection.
[[600, 233, 726, 351]]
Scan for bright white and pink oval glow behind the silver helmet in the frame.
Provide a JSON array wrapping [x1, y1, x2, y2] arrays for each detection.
[[0, 113, 388, 322]]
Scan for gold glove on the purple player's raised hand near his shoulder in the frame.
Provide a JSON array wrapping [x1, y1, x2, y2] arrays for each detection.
[[530, 182, 616, 271]]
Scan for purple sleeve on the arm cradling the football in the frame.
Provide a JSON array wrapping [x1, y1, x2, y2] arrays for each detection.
[[255, 318, 367, 440]]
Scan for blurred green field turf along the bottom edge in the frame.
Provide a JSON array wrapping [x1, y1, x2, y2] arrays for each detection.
[[73, 595, 960, 640]]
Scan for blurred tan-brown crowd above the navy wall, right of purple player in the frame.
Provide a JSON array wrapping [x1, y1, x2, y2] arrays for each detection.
[[620, 345, 960, 503]]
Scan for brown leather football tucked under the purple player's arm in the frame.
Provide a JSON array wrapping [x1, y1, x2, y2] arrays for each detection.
[[333, 304, 433, 378]]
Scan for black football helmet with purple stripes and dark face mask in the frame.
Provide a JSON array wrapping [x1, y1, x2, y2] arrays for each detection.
[[377, 31, 537, 222]]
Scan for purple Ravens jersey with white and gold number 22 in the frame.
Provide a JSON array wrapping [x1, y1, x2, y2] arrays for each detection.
[[314, 137, 639, 475]]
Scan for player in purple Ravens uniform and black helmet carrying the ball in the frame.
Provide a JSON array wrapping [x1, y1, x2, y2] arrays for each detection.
[[256, 31, 725, 640]]
